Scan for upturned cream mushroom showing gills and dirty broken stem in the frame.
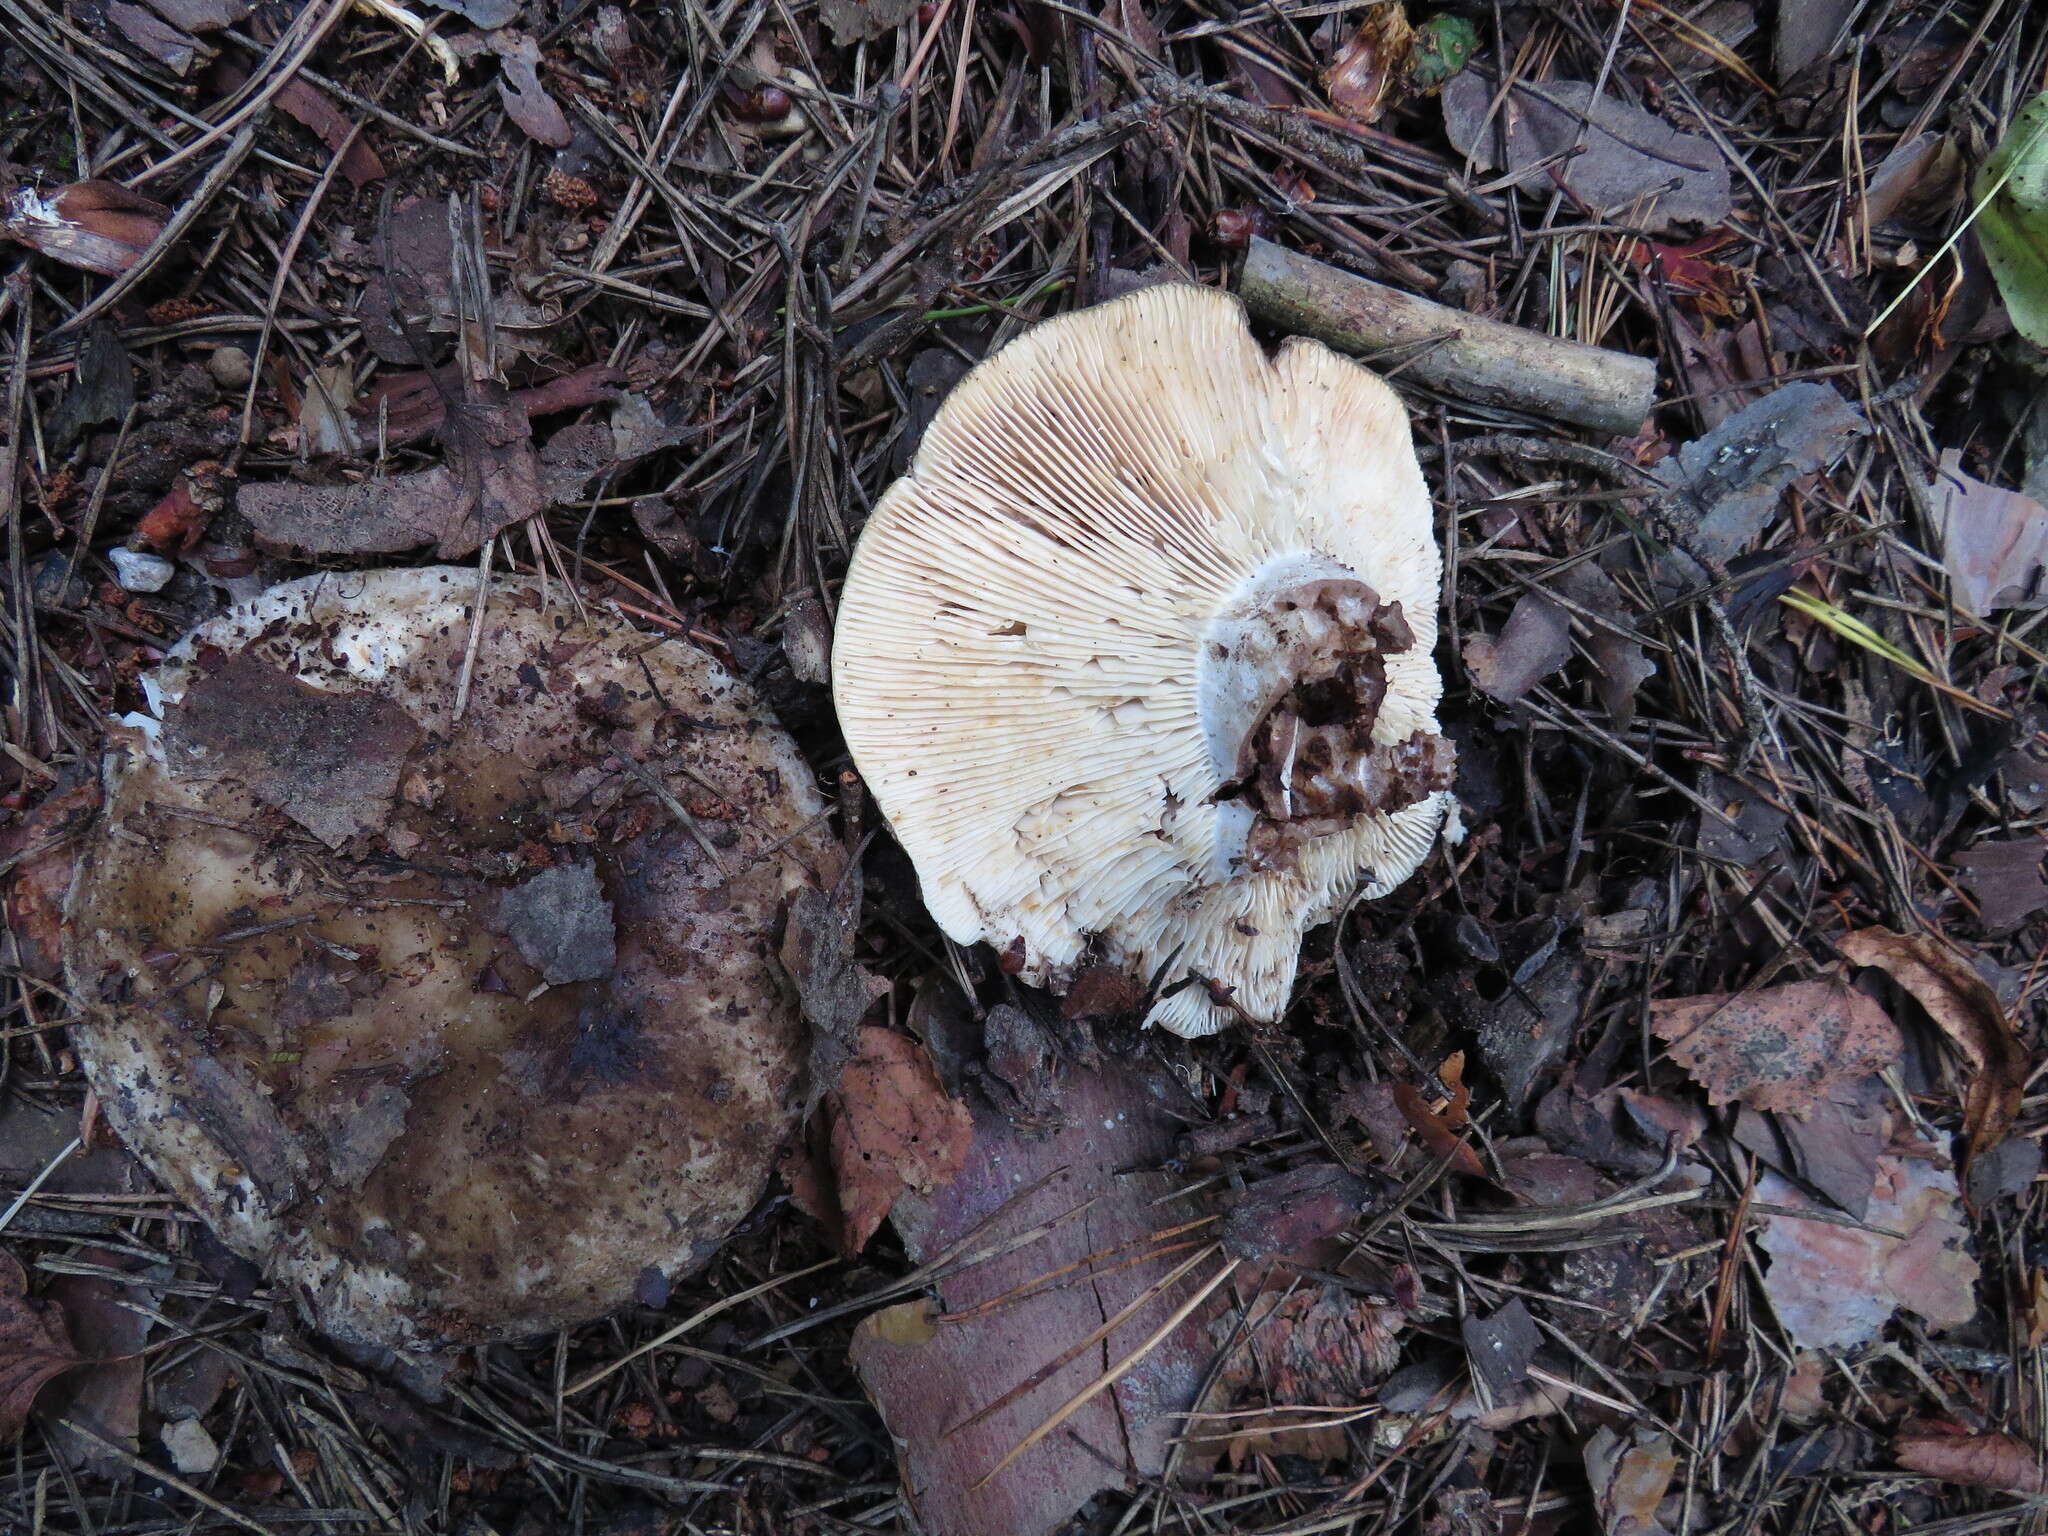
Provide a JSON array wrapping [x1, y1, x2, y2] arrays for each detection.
[[834, 285, 1452, 1034]]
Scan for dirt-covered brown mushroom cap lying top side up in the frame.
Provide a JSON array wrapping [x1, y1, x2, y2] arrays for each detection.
[[66, 567, 836, 1350]]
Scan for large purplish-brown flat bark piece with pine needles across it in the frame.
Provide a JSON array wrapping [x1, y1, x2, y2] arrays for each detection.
[[852, 1061, 1221, 1536]]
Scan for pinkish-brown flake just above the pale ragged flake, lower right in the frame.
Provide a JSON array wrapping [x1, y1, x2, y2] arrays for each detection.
[[1651, 977, 1905, 1114]]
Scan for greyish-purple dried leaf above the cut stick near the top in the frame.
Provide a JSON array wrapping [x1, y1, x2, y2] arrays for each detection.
[[1444, 66, 1733, 229]]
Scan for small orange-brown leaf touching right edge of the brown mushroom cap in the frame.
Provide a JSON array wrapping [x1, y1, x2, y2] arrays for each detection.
[[825, 1026, 975, 1253]]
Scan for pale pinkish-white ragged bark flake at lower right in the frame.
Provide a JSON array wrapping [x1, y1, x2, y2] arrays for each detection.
[[1757, 1155, 1978, 1350]]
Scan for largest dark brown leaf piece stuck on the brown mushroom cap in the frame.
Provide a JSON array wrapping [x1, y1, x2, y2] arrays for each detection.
[[164, 651, 420, 848]]
